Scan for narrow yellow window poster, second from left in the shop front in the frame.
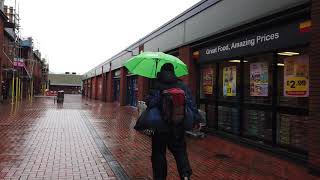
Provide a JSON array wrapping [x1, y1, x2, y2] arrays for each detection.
[[223, 66, 237, 96]]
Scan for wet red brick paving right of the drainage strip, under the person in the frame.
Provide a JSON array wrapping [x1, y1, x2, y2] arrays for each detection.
[[81, 96, 320, 180]]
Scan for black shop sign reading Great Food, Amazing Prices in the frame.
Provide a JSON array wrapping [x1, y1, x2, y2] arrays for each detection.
[[200, 20, 310, 62]]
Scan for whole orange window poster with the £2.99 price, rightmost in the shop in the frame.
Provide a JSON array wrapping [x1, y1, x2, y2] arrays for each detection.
[[283, 55, 309, 97]]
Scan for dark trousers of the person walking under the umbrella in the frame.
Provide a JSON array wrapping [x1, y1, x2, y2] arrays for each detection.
[[151, 127, 192, 180]]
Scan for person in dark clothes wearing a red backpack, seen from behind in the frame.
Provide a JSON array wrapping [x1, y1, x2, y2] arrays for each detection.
[[146, 63, 201, 180]]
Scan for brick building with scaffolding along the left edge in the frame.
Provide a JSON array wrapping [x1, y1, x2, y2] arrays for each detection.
[[0, 2, 48, 103]]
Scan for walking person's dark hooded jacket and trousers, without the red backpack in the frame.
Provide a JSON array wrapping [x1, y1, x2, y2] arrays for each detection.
[[146, 63, 200, 180]]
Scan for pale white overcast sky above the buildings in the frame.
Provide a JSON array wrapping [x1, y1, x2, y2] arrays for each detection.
[[5, 0, 199, 74]]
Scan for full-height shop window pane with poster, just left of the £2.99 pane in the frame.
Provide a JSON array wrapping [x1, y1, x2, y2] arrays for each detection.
[[243, 53, 273, 142]]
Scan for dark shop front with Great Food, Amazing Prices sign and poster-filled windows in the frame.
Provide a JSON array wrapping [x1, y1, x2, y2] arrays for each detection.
[[195, 18, 311, 157]]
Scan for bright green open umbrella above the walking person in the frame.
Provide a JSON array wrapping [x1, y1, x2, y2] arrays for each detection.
[[124, 52, 188, 78]]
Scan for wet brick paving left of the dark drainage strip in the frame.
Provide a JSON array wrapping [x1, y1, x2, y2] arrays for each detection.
[[0, 97, 115, 179]]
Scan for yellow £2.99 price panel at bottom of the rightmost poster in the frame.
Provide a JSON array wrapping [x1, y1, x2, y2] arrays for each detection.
[[285, 77, 309, 97]]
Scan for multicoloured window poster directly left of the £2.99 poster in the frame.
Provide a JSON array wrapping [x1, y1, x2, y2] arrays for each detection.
[[250, 63, 268, 96]]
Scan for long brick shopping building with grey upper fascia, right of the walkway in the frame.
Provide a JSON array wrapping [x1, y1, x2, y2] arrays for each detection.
[[83, 0, 320, 173]]
